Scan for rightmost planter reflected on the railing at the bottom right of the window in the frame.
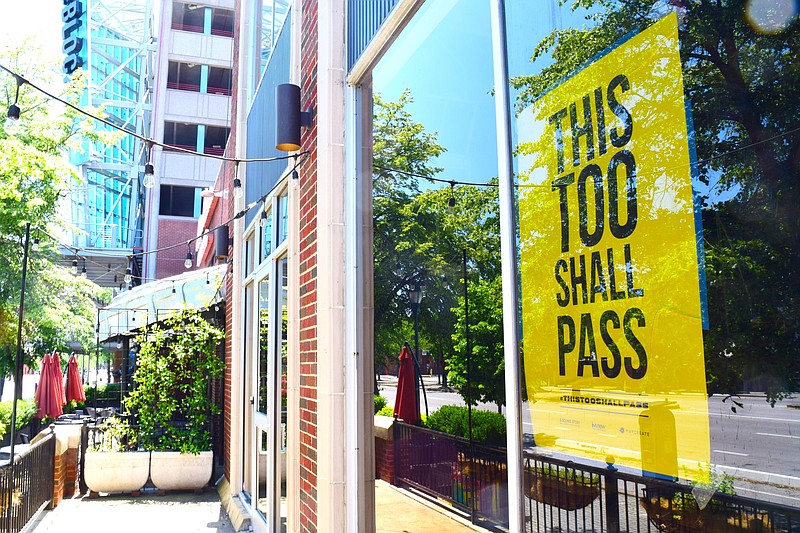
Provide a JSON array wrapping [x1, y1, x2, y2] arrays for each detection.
[[639, 488, 772, 533]]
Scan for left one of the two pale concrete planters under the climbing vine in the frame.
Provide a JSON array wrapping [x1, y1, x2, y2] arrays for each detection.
[[84, 452, 150, 492]]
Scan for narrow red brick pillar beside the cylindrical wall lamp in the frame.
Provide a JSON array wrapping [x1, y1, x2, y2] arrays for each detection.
[[298, 0, 318, 531]]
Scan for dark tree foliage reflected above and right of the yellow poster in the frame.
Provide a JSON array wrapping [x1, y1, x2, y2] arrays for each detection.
[[513, 0, 800, 402]]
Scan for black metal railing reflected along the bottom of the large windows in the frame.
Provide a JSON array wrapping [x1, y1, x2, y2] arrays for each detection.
[[395, 422, 800, 533]]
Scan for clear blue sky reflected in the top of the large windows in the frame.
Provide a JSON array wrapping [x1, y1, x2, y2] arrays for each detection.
[[373, 0, 585, 188]]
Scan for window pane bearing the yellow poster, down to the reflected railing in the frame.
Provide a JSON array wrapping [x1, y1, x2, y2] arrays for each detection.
[[507, 0, 800, 507]]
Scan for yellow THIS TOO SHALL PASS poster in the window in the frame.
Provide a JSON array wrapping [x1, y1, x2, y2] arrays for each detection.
[[518, 14, 710, 479]]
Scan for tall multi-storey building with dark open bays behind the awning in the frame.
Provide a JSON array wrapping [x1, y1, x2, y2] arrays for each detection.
[[143, 1, 234, 281]]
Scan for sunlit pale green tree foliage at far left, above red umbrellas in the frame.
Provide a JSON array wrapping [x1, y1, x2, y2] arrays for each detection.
[[0, 44, 111, 391]]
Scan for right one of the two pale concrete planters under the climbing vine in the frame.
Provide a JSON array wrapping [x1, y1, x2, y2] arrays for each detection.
[[150, 451, 214, 490]]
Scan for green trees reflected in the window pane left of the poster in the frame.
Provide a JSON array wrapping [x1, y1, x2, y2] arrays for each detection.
[[373, 91, 503, 403]]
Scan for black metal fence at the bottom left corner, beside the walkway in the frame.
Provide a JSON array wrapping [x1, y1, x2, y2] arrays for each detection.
[[0, 431, 56, 533]]
